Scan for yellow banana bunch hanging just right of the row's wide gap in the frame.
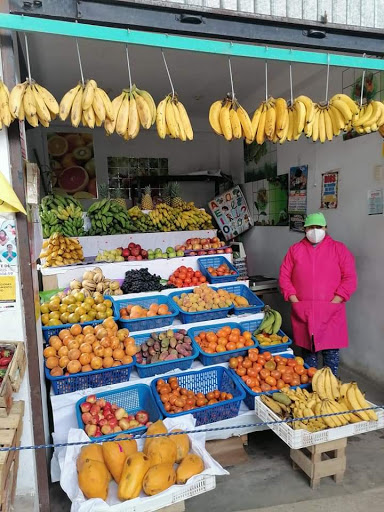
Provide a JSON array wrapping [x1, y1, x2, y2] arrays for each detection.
[[209, 95, 253, 144]]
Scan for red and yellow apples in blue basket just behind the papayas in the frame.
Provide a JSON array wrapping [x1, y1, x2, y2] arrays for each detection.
[[80, 395, 152, 437]]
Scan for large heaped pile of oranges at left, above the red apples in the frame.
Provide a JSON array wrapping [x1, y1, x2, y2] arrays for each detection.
[[43, 318, 137, 377]]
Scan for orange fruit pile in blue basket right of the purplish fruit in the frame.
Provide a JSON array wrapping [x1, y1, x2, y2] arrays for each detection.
[[195, 325, 255, 354]]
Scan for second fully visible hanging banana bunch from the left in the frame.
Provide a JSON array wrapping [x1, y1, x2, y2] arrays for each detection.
[[59, 80, 114, 128]]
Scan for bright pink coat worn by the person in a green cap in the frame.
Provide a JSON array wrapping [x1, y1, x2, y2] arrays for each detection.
[[279, 235, 357, 352]]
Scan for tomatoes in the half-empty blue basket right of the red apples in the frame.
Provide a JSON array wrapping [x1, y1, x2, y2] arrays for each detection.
[[156, 377, 233, 414]]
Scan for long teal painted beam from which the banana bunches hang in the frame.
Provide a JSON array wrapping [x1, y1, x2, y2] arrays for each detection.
[[0, 14, 384, 71]]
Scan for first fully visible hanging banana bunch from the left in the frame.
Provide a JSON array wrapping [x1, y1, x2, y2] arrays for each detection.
[[8, 80, 59, 128]]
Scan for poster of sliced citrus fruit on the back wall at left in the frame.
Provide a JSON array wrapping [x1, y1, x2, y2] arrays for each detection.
[[47, 132, 97, 199]]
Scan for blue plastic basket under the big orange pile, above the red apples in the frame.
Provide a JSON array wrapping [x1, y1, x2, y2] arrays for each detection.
[[44, 357, 135, 395]]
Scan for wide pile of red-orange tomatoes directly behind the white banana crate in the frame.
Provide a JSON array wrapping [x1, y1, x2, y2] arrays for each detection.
[[229, 348, 317, 393]]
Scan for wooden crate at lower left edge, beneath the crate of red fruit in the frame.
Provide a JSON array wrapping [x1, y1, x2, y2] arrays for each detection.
[[0, 401, 24, 512]]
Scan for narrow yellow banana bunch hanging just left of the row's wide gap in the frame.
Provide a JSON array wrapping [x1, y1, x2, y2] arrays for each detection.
[[156, 94, 193, 142]]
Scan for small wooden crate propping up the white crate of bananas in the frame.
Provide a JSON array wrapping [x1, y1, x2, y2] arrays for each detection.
[[291, 438, 347, 489]]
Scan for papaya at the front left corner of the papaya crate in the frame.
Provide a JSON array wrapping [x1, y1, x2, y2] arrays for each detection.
[[78, 459, 110, 500]]
